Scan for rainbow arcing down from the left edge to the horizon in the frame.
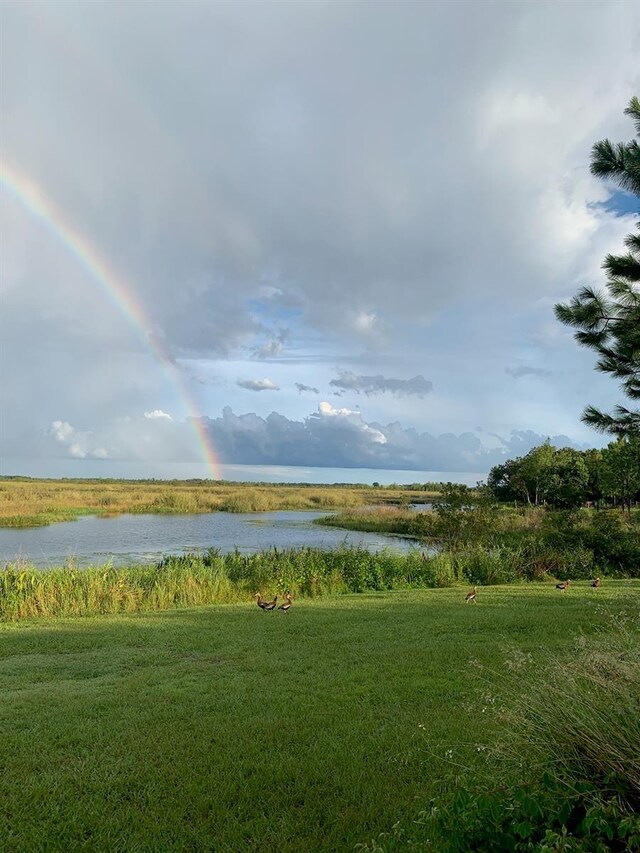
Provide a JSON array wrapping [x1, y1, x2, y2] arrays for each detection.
[[0, 158, 222, 480]]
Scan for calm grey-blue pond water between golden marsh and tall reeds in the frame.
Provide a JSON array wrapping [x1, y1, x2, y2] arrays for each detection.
[[0, 512, 424, 568]]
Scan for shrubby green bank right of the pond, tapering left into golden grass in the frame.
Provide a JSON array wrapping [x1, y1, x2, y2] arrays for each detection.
[[317, 504, 640, 584]]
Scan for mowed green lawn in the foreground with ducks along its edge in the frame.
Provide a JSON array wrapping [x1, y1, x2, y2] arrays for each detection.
[[0, 580, 640, 851]]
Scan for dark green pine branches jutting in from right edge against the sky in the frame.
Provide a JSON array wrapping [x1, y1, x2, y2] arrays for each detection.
[[555, 97, 640, 436]]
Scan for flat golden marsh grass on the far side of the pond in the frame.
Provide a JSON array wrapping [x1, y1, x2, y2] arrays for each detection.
[[0, 478, 434, 527]]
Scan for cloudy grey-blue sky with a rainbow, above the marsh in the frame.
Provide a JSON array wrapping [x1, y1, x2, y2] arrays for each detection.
[[0, 0, 640, 477]]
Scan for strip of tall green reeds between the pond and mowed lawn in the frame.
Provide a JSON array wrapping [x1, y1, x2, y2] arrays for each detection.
[[0, 548, 454, 621]]
